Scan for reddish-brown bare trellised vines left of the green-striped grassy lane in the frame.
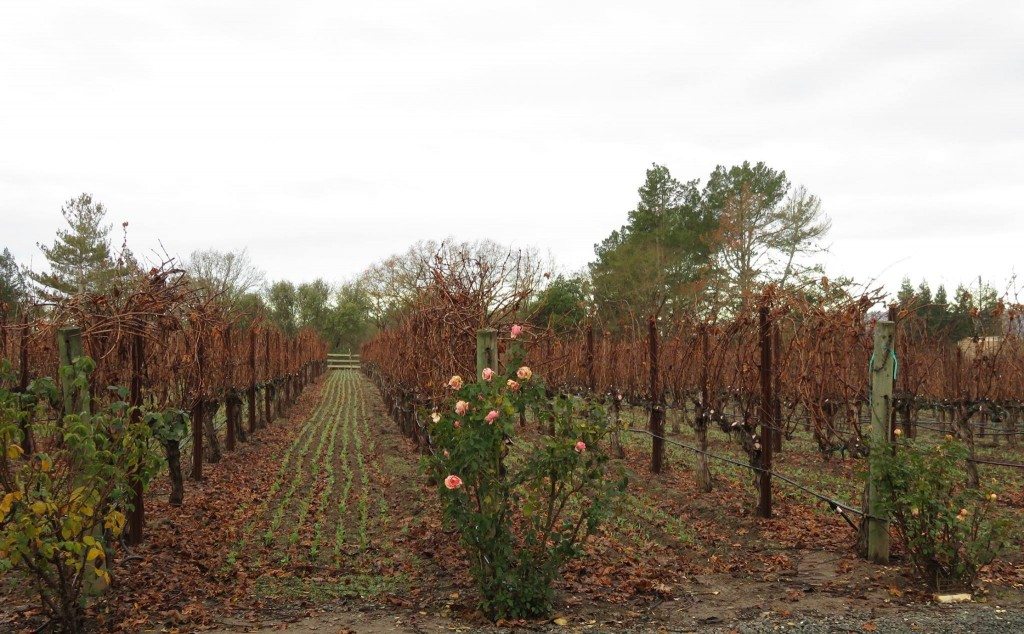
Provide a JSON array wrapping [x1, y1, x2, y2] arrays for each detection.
[[0, 264, 327, 543]]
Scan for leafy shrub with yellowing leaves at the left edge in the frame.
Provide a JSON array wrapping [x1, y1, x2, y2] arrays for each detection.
[[0, 357, 160, 632]]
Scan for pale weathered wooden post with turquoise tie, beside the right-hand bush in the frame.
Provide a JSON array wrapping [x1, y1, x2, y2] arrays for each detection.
[[867, 321, 895, 563]]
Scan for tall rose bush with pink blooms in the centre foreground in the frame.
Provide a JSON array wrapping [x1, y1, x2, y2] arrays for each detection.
[[426, 330, 626, 620]]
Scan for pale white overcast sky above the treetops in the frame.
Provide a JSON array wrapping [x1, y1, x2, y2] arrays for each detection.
[[0, 0, 1024, 294]]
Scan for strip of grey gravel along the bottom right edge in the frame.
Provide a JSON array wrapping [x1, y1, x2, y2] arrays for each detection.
[[720, 605, 1024, 634]]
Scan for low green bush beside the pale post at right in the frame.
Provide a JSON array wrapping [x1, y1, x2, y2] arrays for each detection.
[[869, 434, 1009, 590]]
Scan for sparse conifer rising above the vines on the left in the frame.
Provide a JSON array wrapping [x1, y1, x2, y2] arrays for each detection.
[[30, 194, 116, 300]]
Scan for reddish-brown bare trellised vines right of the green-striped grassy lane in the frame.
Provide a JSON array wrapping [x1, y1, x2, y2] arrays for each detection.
[[361, 288, 1024, 544]]
